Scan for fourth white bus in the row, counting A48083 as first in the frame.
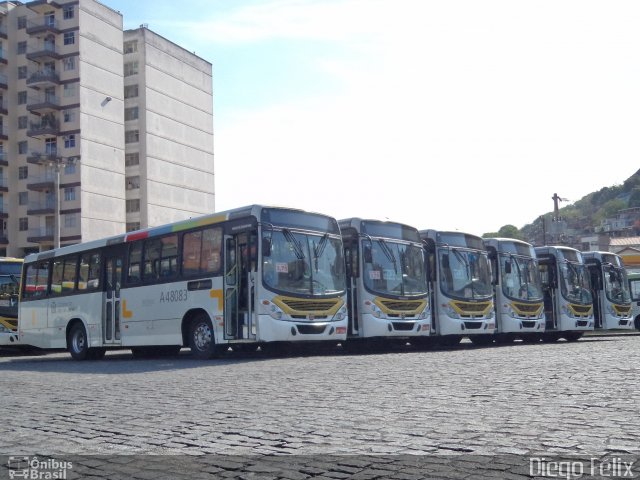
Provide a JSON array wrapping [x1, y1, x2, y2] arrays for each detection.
[[484, 238, 545, 342]]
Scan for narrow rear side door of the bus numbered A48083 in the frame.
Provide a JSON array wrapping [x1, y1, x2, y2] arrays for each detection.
[[102, 250, 124, 345]]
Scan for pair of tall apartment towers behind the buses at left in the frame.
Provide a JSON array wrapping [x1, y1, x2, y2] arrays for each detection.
[[0, 0, 214, 256]]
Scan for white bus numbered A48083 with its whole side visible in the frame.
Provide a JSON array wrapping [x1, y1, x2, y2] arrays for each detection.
[[19, 205, 347, 360]]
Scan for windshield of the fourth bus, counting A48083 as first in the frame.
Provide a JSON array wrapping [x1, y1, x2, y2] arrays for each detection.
[[500, 255, 543, 301]]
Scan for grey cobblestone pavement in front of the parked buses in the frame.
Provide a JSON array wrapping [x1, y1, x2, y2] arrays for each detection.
[[0, 336, 640, 479]]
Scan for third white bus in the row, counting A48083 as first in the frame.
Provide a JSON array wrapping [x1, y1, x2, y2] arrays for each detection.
[[420, 230, 496, 345]]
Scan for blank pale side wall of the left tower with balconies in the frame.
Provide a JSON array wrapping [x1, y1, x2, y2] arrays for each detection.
[[79, 1, 125, 242]]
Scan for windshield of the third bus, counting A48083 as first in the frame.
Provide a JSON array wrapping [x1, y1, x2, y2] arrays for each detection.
[[439, 248, 493, 300]]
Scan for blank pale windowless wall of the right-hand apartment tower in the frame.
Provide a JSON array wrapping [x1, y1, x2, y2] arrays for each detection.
[[125, 28, 215, 227]]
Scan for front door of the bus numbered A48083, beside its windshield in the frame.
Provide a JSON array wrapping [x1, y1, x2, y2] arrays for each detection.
[[224, 232, 257, 340]]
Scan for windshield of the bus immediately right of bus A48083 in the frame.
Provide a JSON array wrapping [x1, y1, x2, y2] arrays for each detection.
[[362, 239, 427, 296]]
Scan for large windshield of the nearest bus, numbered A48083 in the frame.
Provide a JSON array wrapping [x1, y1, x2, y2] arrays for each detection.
[[262, 228, 345, 296]]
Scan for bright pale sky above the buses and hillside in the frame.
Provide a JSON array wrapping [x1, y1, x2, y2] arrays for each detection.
[[101, 0, 640, 235]]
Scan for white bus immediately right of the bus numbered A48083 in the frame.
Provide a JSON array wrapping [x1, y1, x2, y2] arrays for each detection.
[[338, 218, 431, 345]]
